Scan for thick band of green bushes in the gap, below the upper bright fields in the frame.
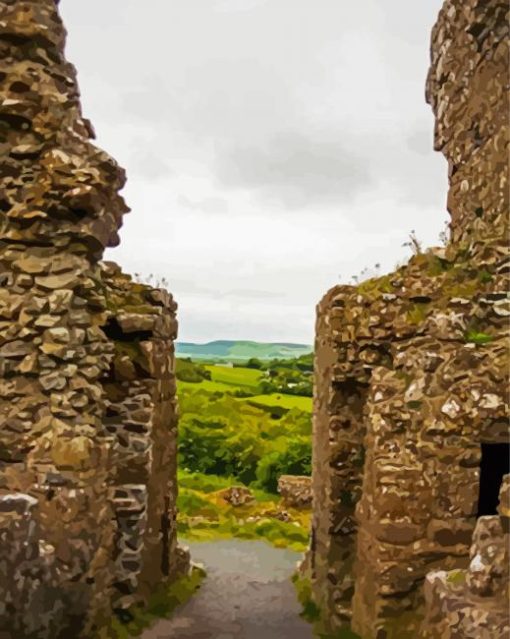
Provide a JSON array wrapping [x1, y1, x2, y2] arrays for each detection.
[[179, 385, 311, 491]]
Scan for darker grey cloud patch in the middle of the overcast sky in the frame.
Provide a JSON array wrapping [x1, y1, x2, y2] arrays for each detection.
[[215, 132, 374, 208]]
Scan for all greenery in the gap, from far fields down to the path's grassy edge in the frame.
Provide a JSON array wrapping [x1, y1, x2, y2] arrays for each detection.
[[178, 355, 312, 551]]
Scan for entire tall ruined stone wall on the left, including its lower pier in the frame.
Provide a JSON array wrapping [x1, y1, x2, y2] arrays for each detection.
[[0, 0, 187, 639]]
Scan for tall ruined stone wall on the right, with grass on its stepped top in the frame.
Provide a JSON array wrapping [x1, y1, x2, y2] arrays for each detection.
[[307, 0, 510, 639]]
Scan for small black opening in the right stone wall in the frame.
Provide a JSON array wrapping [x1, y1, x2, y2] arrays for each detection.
[[477, 444, 510, 517]]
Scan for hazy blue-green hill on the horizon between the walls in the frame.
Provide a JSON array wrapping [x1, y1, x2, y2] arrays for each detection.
[[176, 340, 313, 361]]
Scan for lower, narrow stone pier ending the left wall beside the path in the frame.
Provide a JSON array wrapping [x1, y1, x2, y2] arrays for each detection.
[[101, 262, 186, 606]]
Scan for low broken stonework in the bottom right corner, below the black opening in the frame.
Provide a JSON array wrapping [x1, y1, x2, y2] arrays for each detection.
[[423, 475, 510, 639]]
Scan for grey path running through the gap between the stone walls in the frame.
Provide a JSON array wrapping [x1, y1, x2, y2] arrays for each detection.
[[142, 539, 313, 639]]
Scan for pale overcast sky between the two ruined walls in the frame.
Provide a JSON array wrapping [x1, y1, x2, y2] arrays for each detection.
[[60, 0, 447, 343]]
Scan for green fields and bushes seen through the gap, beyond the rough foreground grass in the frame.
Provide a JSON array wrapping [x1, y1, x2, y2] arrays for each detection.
[[176, 358, 312, 497]]
